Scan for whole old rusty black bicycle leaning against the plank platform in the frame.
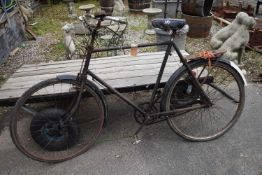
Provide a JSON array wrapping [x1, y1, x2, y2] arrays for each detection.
[[10, 13, 245, 162]]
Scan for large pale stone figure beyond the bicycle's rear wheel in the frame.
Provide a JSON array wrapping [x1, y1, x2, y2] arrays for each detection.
[[210, 12, 255, 63]]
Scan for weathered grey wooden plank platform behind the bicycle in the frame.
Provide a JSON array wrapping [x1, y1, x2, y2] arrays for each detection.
[[0, 51, 188, 106]]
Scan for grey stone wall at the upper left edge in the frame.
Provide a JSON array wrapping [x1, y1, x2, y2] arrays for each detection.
[[0, 9, 25, 63]]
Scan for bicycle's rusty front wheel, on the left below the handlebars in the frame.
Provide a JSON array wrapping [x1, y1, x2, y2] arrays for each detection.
[[10, 78, 104, 162]]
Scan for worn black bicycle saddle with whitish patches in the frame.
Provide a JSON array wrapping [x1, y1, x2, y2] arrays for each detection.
[[152, 18, 186, 30]]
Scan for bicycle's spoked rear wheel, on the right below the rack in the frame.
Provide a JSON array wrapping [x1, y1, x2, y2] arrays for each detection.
[[161, 60, 245, 141]]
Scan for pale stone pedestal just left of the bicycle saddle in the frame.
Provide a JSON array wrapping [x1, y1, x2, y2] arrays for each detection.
[[143, 8, 162, 35]]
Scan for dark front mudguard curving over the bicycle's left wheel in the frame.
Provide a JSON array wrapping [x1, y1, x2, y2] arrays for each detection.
[[56, 75, 108, 127]]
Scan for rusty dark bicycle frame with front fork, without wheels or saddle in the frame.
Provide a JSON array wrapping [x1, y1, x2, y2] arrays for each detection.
[[71, 15, 212, 135]]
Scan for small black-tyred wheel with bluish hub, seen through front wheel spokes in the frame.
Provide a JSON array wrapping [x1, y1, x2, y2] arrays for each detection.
[[30, 108, 79, 151]]
